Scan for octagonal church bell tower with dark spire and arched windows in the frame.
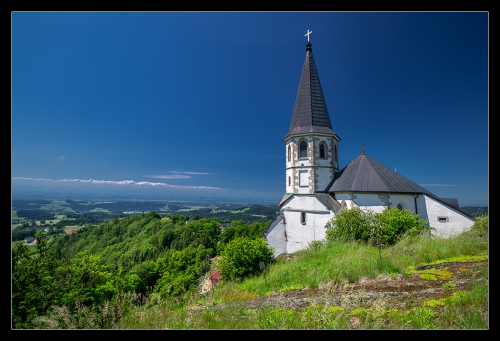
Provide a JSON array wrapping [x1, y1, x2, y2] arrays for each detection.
[[283, 30, 340, 194]]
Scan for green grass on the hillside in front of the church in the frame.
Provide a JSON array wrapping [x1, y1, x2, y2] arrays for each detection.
[[117, 223, 489, 329]]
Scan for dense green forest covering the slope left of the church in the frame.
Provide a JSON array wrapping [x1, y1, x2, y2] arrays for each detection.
[[12, 212, 272, 328]]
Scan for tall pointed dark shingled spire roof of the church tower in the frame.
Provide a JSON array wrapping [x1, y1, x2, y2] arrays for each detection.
[[284, 42, 335, 139]]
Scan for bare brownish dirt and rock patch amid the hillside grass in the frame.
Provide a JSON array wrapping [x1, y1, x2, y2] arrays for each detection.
[[209, 261, 488, 311]]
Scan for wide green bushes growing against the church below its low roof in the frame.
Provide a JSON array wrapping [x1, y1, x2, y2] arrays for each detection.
[[326, 208, 428, 245]]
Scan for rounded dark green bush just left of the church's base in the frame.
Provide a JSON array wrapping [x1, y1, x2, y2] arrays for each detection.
[[219, 237, 274, 280]]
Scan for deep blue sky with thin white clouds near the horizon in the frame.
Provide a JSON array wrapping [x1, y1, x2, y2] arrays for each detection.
[[11, 12, 489, 206]]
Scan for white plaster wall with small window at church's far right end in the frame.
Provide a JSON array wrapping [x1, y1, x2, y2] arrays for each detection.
[[425, 196, 474, 238]]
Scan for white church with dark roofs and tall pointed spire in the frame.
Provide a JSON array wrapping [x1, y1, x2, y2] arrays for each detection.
[[264, 30, 474, 257]]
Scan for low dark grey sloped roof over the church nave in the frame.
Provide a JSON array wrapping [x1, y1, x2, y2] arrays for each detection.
[[326, 152, 436, 197]]
